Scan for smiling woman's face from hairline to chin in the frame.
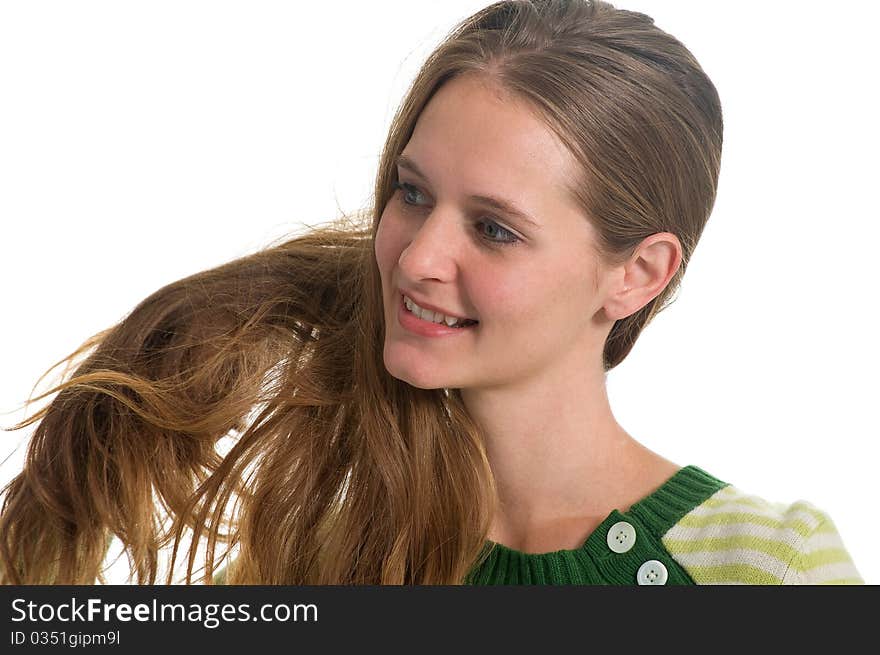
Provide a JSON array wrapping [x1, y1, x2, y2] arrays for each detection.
[[375, 76, 608, 389]]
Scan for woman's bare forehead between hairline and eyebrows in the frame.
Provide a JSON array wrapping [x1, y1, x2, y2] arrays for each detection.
[[404, 75, 578, 204]]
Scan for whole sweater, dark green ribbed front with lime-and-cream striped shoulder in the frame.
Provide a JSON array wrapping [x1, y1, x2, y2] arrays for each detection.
[[464, 466, 865, 585]]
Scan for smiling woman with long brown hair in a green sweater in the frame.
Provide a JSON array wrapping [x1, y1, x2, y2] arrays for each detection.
[[0, 0, 861, 584]]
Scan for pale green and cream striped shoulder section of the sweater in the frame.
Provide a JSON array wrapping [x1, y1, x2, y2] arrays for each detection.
[[662, 485, 864, 584]]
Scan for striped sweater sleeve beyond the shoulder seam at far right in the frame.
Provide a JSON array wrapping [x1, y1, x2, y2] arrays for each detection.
[[782, 512, 865, 585]]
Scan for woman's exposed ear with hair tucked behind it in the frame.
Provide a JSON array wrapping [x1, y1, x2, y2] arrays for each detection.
[[602, 232, 682, 321]]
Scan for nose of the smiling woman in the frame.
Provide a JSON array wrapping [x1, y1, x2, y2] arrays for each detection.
[[398, 208, 462, 281]]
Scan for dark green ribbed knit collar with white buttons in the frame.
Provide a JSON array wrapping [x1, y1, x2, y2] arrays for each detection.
[[465, 465, 727, 585]]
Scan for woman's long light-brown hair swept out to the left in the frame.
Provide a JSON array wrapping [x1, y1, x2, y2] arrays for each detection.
[[0, 0, 723, 585]]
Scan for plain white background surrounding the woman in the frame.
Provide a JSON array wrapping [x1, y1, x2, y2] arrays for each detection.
[[0, 0, 880, 584]]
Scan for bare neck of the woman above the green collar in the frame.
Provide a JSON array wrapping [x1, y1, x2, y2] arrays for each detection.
[[461, 367, 675, 543]]
